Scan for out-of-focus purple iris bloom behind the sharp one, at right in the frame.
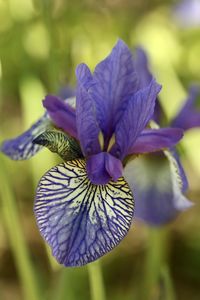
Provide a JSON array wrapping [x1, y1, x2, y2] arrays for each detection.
[[124, 48, 195, 226]]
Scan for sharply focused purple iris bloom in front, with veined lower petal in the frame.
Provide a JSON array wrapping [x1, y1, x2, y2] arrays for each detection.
[[1, 40, 186, 266]]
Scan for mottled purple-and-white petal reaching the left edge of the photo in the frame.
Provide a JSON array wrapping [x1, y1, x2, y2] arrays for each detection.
[[0, 113, 51, 160]]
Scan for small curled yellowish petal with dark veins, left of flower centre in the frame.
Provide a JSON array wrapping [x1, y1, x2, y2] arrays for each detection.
[[33, 129, 83, 161]]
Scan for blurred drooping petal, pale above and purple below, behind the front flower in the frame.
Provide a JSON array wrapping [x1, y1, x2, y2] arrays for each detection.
[[124, 152, 192, 226]]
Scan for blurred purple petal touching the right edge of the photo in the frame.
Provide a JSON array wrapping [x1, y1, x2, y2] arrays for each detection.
[[171, 85, 200, 130]]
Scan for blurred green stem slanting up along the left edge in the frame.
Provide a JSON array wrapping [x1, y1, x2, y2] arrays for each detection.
[[0, 158, 40, 300]]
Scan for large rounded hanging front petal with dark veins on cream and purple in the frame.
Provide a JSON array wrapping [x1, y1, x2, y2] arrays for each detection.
[[35, 159, 134, 266]]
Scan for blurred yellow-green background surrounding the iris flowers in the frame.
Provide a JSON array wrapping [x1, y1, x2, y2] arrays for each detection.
[[0, 0, 200, 300]]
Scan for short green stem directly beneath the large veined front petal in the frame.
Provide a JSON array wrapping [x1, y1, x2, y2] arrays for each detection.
[[87, 261, 106, 300]]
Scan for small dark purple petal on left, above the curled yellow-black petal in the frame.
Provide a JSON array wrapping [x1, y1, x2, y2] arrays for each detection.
[[43, 95, 77, 138]]
